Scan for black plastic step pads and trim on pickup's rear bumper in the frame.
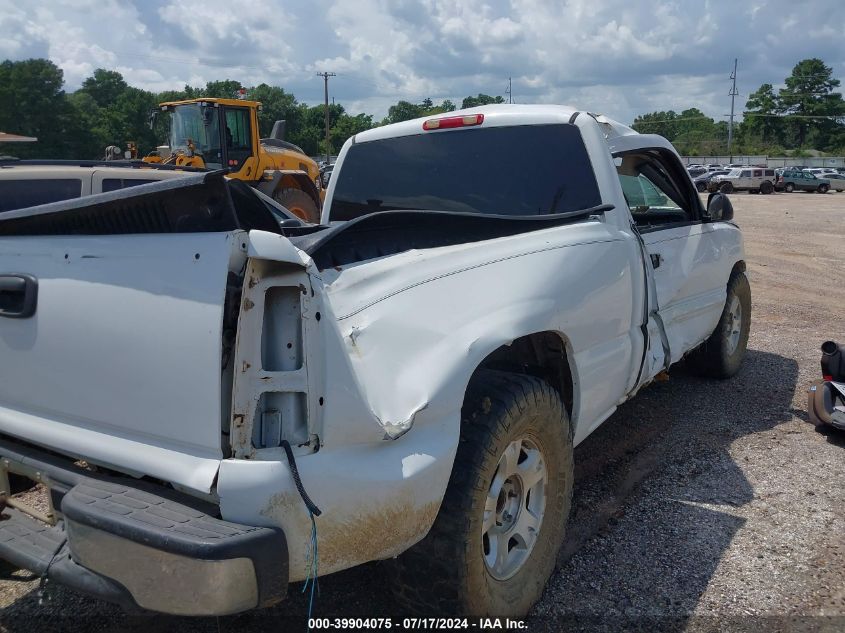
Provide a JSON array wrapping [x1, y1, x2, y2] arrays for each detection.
[[0, 439, 289, 606]]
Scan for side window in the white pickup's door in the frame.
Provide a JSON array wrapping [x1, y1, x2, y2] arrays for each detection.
[[616, 154, 696, 230]]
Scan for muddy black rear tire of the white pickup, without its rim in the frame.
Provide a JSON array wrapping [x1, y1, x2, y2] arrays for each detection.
[[390, 370, 573, 617]]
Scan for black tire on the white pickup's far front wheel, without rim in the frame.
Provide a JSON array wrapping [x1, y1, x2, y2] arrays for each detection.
[[687, 272, 751, 378]]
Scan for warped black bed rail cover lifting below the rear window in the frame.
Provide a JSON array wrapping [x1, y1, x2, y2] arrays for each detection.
[[290, 204, 613, 270]]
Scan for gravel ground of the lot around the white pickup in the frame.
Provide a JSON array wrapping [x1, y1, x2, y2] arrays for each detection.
[[0, 193, 845, 633]]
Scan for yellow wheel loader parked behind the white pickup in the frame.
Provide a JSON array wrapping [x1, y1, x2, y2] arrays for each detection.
[[143, 99, 325, 222]]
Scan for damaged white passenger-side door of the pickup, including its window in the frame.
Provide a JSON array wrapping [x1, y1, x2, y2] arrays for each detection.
[[614, 148, 736, 368]]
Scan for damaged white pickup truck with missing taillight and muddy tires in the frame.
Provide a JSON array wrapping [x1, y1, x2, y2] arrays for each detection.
[[0, 106, 751, 615]]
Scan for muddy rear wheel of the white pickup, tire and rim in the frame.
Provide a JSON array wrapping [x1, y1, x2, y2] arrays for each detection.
[[391, 370, 573, 617]]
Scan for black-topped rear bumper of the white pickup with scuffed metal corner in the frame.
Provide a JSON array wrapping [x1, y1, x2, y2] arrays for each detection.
[[0, 439, 288, 615]]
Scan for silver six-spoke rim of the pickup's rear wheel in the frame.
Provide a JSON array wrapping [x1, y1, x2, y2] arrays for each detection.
[[481, 438, 548, 580]]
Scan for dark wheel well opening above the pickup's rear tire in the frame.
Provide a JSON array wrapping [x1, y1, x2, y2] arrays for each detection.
[[476, 332, 573, 420]]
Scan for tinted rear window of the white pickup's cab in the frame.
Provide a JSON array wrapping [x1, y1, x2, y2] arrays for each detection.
[[331, 124, 601, 220]]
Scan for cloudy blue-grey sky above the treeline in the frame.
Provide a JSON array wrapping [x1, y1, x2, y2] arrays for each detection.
[[0, 0, 845, 123]]
